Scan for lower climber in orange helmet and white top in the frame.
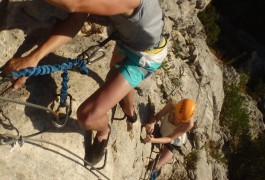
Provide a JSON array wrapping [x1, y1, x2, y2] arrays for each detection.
[[144, 99, 196, 176]]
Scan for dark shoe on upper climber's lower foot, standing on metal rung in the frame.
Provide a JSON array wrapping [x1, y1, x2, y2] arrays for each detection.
[[84, 125, 111, 166]]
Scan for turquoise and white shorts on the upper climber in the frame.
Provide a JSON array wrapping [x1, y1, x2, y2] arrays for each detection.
[[114, 41, 167, 88]]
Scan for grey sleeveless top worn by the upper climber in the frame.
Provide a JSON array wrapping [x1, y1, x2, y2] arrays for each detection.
[[110, 0, 164, 51]]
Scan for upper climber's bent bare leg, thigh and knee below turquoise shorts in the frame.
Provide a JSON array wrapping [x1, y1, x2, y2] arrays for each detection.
[[77, 72, 132, 141]]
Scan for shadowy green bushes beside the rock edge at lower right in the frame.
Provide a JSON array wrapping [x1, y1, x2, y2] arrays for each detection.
[[219, 72, 265, 180]]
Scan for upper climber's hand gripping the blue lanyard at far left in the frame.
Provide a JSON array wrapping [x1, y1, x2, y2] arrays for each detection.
[[4, 56, 37, 89]]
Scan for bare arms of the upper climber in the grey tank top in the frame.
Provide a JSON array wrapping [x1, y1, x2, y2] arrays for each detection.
[[5, 0, 140, 87]]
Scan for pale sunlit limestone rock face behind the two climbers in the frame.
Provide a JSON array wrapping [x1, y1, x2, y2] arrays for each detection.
[[0, 0, 258, 180]]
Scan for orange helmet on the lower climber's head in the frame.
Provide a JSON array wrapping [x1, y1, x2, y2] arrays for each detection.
[[175, 99, 196, 122]]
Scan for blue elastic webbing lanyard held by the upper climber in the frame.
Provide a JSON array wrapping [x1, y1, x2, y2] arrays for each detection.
[[8, 58, 88, 106]]
